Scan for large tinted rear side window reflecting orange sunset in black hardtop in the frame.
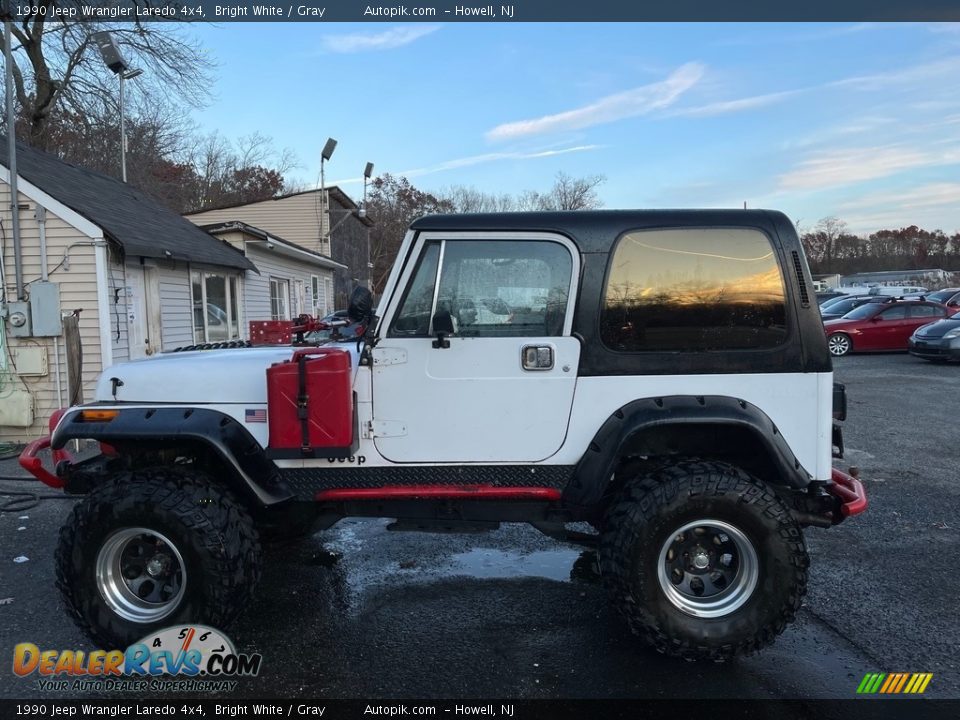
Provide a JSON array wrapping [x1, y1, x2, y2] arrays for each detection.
[[600, 228, 787, 352]]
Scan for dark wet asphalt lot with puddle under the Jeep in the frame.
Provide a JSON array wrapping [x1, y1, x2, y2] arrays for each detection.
[[0, 355, 960, 699]]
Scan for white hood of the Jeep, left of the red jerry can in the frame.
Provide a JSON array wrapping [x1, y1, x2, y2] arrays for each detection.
[[94, 346, 356, 405]]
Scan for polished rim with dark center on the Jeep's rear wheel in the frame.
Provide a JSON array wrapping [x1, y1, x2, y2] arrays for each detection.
[[657, 520, 760, 618]]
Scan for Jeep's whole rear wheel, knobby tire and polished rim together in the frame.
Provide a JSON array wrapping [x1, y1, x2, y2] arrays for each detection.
[[600, 461, 808, 661]]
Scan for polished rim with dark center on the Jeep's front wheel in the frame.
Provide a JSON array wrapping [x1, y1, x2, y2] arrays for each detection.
[[96, 528, 187, 623]]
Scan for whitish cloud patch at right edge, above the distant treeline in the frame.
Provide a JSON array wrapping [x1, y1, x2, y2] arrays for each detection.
[[779, 145, 960, 190]]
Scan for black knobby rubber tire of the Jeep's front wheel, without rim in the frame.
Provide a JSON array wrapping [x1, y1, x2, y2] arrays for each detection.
[[56, 468, 261, 649]]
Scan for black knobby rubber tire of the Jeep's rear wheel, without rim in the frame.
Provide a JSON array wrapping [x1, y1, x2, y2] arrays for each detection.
[[600, 461, 809, 662]]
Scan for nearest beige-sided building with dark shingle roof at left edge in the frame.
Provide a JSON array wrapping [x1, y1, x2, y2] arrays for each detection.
[[0, 137, 257, 442]]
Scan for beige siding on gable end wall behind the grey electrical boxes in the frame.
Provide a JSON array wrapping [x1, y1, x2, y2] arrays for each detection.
[[0, 182, 102, 442]]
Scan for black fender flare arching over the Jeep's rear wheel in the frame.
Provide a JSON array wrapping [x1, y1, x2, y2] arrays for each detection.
[[563, 395, 811, 511]]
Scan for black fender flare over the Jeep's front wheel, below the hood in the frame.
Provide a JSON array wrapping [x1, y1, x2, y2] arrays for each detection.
[[50, 406, 293, 506]]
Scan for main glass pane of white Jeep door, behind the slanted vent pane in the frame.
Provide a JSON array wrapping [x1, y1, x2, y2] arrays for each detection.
[[436, 240, 573, 337]]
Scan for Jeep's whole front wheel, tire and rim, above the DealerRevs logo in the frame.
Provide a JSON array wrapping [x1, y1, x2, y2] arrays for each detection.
[[56, 468, 260, 648]]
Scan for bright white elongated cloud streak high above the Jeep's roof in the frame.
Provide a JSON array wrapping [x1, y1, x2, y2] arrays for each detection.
[[486, 63, 705, 140]]
